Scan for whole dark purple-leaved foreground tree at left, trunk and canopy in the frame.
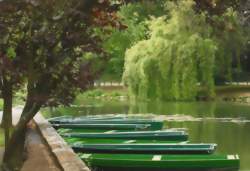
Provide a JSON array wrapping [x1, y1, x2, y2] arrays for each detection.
[[0, 0, 119, 170]]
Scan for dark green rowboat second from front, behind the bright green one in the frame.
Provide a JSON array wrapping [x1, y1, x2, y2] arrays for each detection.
[[71, 144, 217, 154]]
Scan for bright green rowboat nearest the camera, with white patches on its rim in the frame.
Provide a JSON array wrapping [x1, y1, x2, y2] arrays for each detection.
[[79, 154, 240, 171]]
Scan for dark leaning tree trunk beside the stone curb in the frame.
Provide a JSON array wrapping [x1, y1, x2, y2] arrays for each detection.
[[3, 104, 41, 170]]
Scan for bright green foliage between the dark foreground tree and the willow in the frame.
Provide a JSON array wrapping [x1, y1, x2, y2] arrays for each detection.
[[103, 0, 164, 79]]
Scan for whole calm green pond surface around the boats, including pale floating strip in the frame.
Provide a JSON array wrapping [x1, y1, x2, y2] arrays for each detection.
[[45, 100, 250, 171]]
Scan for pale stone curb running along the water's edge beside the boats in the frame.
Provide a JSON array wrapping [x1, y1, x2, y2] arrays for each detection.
[[34, 113, 90, 171]]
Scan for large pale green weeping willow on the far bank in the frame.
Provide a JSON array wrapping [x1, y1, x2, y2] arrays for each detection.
[[123, 0, 217, 100]]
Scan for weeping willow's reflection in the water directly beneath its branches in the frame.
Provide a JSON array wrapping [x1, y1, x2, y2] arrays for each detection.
[[129, 100, 216, 117]]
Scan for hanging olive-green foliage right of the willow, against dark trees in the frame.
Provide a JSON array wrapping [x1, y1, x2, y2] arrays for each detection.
[[212, 8, 247, 81]]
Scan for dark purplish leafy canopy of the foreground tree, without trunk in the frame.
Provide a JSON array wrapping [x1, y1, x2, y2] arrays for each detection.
[[0, 1, 109, 104]]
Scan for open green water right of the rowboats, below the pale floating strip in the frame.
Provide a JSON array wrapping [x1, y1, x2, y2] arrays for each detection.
[[176, 121, 250, 170]]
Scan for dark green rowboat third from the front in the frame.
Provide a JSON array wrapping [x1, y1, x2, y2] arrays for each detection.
[[61, 131, 188, 141]]
